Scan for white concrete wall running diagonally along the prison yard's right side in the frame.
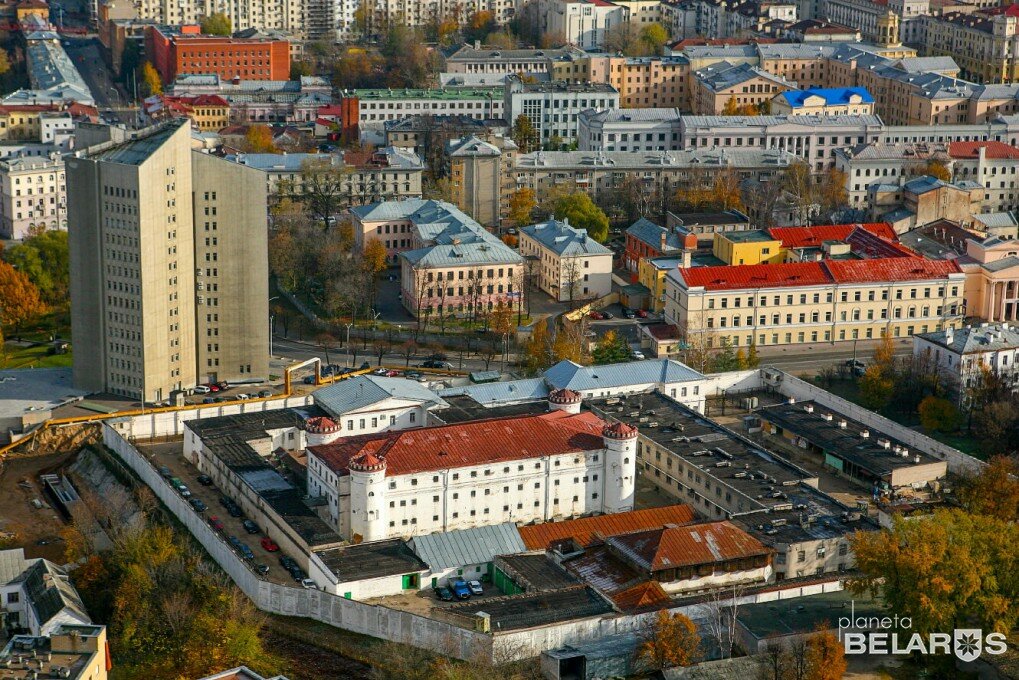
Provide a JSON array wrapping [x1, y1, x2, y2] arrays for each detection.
[[762, 368, 986, 475]]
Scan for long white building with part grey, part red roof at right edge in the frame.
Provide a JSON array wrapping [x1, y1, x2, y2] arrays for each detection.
[[836, 142, 1019, 212]]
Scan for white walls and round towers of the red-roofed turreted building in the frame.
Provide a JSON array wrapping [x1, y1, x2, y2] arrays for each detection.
[[308, 416, 636, 540]]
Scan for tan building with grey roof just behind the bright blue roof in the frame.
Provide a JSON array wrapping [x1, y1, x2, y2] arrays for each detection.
[[691, 61, 796, 115]]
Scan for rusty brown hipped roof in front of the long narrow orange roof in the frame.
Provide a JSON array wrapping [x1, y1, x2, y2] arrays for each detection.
[[605, 522, 770, 572]]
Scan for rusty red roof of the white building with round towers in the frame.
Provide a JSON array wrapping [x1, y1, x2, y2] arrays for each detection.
[[308, 411, 605, 477]]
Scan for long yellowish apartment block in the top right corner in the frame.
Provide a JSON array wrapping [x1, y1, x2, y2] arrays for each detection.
[[923, 5, 1019, 84]]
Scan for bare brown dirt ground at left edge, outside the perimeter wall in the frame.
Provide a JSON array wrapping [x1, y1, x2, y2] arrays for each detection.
[[0, 452, 76, 564]]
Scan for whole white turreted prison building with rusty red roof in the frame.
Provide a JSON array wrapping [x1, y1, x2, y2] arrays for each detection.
[[308, 409, 637, 541]]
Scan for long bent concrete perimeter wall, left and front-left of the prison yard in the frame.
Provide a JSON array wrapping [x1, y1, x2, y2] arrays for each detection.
[[103, 422, 492, 659]]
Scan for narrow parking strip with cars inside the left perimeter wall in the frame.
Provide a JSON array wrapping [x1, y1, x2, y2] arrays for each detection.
[[138, 440, 301, 585]]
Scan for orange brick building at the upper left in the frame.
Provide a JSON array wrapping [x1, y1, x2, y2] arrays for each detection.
[[145, 25, 290, 83]]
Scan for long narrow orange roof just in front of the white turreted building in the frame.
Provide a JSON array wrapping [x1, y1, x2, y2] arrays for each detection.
[[520, 505, 694, 551]]
